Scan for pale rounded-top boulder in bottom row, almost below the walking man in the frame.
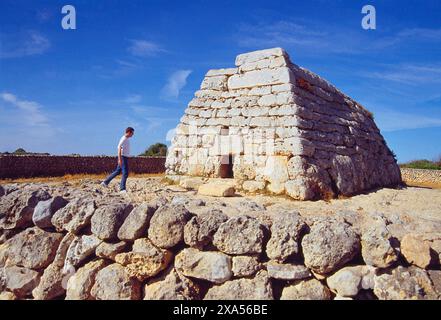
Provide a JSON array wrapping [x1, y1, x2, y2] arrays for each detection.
[[90, 263, 141, 300]]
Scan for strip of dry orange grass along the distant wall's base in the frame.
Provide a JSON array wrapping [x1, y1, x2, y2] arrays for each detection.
[[0, 173, 164, 184]]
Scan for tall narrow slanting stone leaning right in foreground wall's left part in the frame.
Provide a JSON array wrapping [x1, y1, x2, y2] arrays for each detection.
[[32, 233, 75, 300]]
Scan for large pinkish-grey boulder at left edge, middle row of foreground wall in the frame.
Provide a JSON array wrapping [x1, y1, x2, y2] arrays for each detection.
[[4, 227, 63, 270]]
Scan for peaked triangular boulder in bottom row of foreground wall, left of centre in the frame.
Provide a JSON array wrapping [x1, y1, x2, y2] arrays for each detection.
[[144, 268, 201, 300]]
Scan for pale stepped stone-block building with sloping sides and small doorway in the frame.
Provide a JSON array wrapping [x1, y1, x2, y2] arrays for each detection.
[[166, 48, 401, 200]]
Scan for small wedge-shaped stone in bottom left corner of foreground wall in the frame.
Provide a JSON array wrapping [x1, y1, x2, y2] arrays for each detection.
[[3, 266, 40, 298]]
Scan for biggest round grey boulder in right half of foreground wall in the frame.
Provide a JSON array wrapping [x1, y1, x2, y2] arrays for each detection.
[[302, 218, 360, 274]]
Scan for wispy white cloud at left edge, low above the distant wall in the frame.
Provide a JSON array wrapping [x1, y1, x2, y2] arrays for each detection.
[[0, 92, 48, 126]]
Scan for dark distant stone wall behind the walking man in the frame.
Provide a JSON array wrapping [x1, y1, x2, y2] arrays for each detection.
[[0, 156, 165, 179]]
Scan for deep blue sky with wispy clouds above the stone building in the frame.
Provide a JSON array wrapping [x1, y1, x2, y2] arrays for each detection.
[[0, 0, 441, 161]]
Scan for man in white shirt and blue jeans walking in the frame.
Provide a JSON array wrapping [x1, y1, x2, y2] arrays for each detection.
[[101, 127, 135, 194]]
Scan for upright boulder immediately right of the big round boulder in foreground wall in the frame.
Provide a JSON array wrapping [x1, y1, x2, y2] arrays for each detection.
[[361, 222, 398, 268]]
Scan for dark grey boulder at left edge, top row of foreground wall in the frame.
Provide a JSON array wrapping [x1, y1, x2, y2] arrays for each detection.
[[0, 188, 50, 229]]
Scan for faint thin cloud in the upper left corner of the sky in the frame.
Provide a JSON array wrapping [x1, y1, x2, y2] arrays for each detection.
[[0, 31, 51, 59]]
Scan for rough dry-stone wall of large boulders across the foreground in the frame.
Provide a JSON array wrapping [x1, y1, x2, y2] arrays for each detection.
[[0, 184, 441, 300]]
